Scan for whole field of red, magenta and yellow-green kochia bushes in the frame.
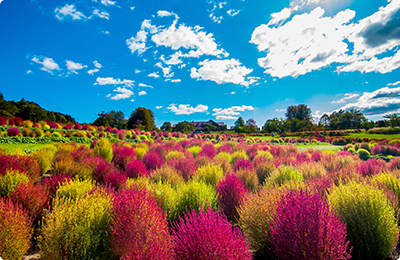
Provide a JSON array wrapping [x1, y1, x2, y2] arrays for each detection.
[[0, 123, 400, 259]]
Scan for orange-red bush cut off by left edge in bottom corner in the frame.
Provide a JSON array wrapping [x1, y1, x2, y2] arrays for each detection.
[[0, 198, 33, 259]]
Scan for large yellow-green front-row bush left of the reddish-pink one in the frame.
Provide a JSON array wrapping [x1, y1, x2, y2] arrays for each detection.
[[38, 189, 113, 260]]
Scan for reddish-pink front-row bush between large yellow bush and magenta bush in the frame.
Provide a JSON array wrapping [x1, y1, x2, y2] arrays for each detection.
[[110, 188, 175, 259]]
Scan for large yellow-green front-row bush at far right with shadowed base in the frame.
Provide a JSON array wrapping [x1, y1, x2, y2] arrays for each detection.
[[328, 182, 399, 260]]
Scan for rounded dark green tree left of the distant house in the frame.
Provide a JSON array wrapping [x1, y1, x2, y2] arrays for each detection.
[[127, 107, 156, 131]]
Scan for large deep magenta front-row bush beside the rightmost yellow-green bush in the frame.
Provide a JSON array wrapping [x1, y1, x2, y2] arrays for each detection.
[[269, 191, 351, 260]]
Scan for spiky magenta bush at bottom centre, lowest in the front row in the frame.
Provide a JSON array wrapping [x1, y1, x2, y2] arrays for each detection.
[[173, 209, 252, 260]]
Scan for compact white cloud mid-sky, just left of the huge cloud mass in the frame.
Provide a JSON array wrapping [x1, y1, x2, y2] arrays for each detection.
[[190, 59, 257, 86]]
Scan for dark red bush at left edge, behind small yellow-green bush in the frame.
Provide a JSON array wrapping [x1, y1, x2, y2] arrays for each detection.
[[0, 154, 42, 179]]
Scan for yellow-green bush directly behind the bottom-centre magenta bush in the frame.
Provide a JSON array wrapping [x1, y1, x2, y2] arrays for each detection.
[[170, 181, 219, 220]]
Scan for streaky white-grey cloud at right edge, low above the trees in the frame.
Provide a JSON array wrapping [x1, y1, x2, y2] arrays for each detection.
[[340, 87, 400, 116]]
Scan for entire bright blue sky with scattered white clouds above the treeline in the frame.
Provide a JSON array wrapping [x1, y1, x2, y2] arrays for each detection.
[[0, 0, 400, 126]]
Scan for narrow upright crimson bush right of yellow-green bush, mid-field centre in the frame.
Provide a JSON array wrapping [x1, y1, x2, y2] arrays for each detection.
[[217, 174, 246, 222]]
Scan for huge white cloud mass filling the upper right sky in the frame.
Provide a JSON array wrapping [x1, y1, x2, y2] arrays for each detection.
[[251, 0, 400, 78]]
